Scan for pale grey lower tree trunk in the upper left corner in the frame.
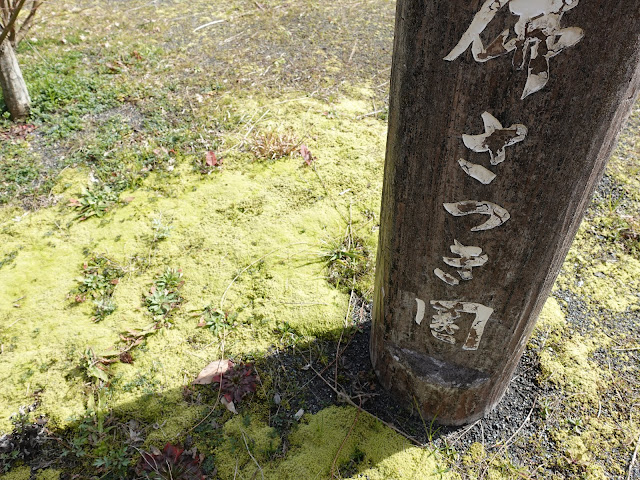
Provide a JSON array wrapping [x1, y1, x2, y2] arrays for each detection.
[[0, 40, 31, 120]]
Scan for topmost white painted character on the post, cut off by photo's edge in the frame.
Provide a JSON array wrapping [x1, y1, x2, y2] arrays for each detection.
[[444, 0, 584, 99]]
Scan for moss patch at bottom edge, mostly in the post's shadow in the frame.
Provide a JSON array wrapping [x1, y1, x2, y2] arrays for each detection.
[[216, 407, 455, 480]]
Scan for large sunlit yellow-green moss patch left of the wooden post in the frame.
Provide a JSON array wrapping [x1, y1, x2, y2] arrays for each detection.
[[0, 94, 383, 429]]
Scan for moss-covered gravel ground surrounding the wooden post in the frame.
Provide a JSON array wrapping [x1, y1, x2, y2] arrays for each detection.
[[0, 0, 640, 480]]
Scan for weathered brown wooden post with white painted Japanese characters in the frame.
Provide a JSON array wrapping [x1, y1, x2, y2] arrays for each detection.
[[371, 0, 640, 425]]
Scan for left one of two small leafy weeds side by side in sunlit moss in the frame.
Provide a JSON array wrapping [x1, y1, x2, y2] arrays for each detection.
[[71, 255, 125, 322]]
